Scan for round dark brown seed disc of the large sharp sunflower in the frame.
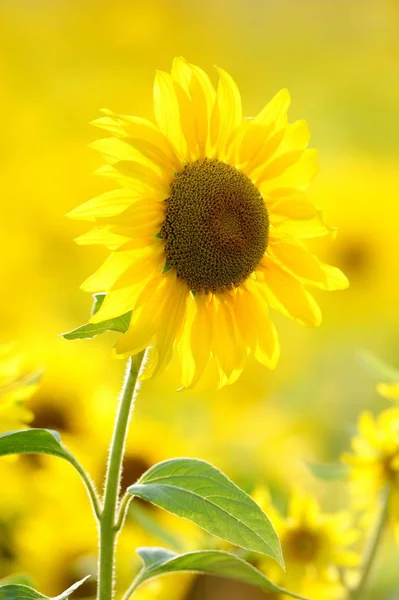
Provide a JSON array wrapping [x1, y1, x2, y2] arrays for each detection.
[[161, 159, 269, 293]]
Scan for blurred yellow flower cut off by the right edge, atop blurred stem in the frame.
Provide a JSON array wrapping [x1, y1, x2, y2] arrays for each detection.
[[342, 408, 399, 524]]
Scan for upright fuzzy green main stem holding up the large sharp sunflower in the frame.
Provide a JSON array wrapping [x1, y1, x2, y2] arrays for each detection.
[[97, 352, 144, 600]]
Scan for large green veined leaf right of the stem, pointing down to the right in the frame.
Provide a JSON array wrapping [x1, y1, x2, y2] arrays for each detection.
[[128, 458, 284, 565]]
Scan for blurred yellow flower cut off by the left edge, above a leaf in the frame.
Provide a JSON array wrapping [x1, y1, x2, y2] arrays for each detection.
[[0, 344, 37, 433]]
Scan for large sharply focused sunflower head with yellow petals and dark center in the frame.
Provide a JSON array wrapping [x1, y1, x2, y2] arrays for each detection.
[[70, 58, 347, 387]]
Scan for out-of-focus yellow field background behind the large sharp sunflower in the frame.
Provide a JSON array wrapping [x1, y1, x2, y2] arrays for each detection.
[[0, 0, 399, 600]]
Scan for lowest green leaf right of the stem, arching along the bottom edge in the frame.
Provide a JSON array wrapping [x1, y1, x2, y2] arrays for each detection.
[[130, 548, 310, 600]]
